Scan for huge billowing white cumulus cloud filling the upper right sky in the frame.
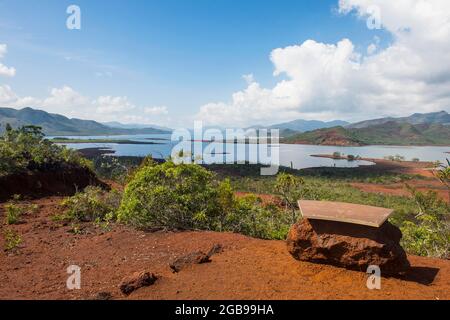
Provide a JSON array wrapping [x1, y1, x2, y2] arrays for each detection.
[[196, 0, 450, 126]]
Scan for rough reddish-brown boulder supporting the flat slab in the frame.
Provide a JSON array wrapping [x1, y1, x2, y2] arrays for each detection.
[[287, 219, 410, 275]]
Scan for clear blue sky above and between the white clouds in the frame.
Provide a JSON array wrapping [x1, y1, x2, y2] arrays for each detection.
[[0, 0, 446, 126]]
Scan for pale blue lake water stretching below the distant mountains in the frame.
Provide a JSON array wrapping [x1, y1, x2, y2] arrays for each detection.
[[53, 134, 450, 169]]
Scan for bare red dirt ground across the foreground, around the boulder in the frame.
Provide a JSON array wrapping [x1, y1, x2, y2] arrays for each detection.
[[0, 197, 450, 300]]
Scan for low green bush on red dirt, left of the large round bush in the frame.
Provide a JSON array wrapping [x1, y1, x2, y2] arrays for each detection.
[[59, 187, 121, 223]]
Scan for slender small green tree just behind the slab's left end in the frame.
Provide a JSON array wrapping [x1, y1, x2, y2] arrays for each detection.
[[275, 173, 304, 223]]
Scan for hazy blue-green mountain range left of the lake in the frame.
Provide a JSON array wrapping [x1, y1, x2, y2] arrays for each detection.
[[0, 108, 168, 136]]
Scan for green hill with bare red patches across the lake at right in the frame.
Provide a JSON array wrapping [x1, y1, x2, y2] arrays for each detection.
[[282, 121, 450, 146]]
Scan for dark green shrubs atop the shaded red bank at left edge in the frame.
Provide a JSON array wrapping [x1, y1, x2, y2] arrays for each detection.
[[0, 126, 91, 176]]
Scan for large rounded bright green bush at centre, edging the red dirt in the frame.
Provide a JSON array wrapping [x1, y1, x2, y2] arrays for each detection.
[[118, 161, 232, 230]]
